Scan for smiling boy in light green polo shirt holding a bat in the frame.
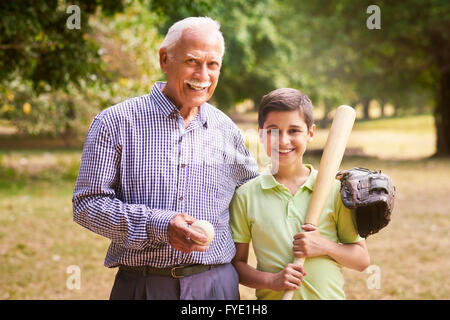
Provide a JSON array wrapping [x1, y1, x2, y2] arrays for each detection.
[[230, 88, 370, 300]]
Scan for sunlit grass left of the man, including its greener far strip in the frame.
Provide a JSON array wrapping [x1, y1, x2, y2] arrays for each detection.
[[0, 150, 114, 299]]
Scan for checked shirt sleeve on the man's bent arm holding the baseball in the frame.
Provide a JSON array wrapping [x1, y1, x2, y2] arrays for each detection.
[[72, 116, 177, 249]]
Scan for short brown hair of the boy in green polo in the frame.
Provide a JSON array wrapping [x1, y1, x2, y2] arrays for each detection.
[[258, 88, 314, 129]]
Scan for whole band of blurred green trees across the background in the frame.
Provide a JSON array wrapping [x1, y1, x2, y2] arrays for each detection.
[[0, 0, 450, 156]]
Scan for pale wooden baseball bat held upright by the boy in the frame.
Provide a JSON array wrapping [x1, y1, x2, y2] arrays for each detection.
[[283, 105, 356, 300]]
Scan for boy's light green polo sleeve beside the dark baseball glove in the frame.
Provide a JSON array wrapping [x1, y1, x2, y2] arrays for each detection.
[[334, 184, 364, 243]]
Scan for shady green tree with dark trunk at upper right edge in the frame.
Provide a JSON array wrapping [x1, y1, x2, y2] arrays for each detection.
[[283, 0, 450, 156]]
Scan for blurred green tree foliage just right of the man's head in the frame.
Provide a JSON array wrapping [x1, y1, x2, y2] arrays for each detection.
[[153, 0, 287, 110]]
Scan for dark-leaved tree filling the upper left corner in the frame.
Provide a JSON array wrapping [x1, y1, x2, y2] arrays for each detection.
[[0, 0, 129, 139]]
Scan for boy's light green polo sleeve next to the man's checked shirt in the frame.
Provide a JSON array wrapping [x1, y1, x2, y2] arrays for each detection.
[[229, 189, 252, 243]]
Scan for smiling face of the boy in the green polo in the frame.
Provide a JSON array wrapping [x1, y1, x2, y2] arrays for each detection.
[[259, 111, 316, 168]]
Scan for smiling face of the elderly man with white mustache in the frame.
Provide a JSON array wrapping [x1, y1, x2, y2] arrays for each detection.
[[159, 30, 222, 108]]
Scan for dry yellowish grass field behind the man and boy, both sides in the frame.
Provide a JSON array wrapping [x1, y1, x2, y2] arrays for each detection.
[[0, 116, 450, 299]]
